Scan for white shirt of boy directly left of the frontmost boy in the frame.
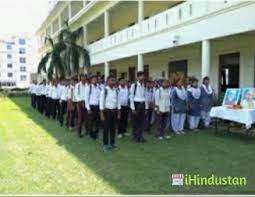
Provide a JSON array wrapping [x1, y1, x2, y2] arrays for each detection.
[[85, 84, 101, 110]]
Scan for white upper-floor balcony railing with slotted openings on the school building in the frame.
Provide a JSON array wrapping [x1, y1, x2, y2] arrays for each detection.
[[88, 0, 241, 54]]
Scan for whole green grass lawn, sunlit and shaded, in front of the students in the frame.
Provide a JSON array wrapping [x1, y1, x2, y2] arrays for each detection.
[[0, 97, 255, 194]]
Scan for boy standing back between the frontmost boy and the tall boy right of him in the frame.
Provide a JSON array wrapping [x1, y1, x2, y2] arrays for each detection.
[[118, 78, 129, 138]]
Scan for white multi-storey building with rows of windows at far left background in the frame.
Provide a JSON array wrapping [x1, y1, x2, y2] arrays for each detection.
[[0, 36, 31, 89]]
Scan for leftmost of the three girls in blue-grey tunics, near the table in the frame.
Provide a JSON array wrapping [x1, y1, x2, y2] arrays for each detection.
[[171, 74, 187, 135]]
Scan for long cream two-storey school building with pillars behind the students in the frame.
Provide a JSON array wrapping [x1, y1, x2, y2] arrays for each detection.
[[37, 0, 255, 92]]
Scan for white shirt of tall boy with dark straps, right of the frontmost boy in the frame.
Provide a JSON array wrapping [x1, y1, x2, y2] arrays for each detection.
[[130, 82, 148, 110]]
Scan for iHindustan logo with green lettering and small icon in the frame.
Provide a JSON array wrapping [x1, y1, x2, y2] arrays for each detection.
[[172, 174, 247, 186]]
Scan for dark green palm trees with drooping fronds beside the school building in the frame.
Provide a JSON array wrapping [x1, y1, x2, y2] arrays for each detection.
[[38, 22, 90, 80]]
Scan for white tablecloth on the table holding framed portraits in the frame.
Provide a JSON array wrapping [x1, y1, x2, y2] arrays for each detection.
[[210, 106, 255, 129]]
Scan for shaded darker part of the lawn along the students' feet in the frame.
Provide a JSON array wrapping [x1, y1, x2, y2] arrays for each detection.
[[11, 97, 255, 194]]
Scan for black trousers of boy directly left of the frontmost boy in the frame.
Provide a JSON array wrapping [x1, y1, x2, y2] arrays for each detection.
[[88, 105, 100, 139]]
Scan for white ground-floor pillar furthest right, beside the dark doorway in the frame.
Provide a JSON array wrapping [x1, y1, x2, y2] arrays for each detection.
[[201, 40, 211, 79]]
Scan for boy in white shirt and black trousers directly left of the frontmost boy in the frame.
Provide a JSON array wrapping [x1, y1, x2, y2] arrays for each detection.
[[85, 76, 101, 140]]
